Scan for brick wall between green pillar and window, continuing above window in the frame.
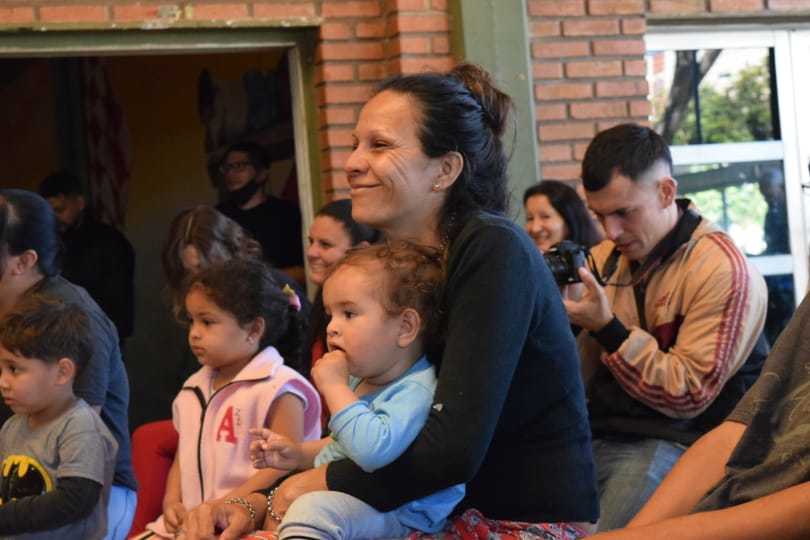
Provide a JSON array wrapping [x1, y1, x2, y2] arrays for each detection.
[[528, 0, 810, 179]]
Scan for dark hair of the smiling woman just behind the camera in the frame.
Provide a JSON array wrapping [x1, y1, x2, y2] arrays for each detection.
[[523, 180, 601, 247]]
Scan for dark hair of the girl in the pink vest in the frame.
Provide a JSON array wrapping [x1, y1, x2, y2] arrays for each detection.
[[181, 259, 305, 369]]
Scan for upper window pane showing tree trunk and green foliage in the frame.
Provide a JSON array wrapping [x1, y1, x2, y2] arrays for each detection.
[[647, 48, 780, 145]]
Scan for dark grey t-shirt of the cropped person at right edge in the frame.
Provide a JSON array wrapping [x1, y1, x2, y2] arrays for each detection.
[[693, 297, 810, 512]]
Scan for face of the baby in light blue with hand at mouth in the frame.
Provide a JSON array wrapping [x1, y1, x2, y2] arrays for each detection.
[[323, 265, 410, 379]]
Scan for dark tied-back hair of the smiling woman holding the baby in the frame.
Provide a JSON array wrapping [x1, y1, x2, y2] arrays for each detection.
[[377, 64, 512, 245]]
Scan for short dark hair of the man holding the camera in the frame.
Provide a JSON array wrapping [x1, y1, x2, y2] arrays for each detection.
[[582, 124, 672, 191]]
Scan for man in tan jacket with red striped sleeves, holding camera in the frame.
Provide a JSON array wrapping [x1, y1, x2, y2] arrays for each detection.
[[564, 124, 768, 530]]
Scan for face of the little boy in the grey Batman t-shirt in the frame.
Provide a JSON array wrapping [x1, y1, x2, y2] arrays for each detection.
[[0, 345, 61, 420]]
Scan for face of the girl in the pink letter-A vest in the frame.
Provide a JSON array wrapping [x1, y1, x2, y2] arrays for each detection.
[[186, 288, 260, 374]]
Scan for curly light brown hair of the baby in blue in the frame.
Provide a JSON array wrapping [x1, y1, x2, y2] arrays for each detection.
[[336, 240, 445, 357]]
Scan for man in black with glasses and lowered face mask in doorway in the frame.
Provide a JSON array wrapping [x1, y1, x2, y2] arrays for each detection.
[[217, 142, 304, 283]]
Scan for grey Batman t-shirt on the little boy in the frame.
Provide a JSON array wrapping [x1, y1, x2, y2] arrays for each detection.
[[0, 399, 118, 540]]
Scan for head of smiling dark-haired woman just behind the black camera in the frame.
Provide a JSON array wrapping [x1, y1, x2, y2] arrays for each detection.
[[523, 180, 602, 253]]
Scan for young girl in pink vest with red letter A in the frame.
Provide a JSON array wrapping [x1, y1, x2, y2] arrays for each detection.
[[144, 259, 321, 538]]
